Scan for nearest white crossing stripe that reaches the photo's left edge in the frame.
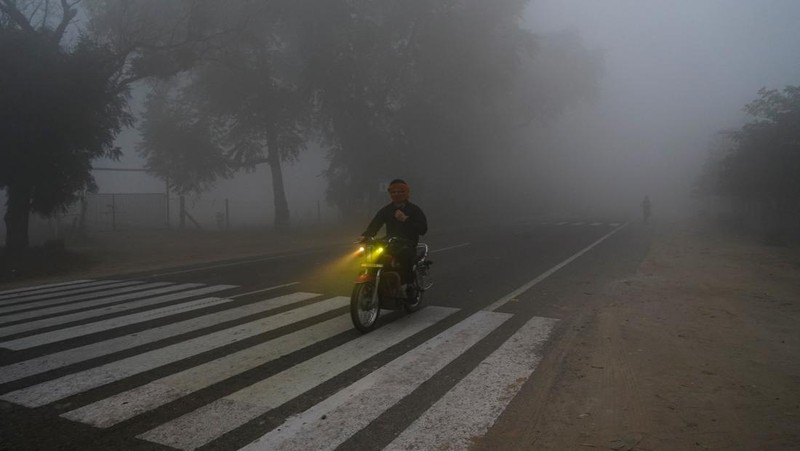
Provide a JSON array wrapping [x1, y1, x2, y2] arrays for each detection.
[[0, 297, 350, 407]]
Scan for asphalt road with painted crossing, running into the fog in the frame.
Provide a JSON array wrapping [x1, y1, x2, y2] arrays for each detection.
[[0, 220, 648, 450]]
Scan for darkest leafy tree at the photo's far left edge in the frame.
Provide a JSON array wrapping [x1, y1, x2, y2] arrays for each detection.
[[0, 0, 130, 251]]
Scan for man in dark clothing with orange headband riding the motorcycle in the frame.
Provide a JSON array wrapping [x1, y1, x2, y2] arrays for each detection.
[[360, 179, 428, 292]]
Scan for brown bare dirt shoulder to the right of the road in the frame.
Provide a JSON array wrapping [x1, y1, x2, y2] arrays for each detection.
[[485, 223, 800, 450]]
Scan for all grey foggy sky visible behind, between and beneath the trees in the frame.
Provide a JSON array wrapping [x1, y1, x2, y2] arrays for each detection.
[[0, 0, 800, 244]]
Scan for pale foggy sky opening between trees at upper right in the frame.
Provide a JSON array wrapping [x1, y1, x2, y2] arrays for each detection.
[[526, 0, 800, 222]]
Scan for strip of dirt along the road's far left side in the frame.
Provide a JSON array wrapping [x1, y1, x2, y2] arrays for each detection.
[[0, 227, 358, 290]]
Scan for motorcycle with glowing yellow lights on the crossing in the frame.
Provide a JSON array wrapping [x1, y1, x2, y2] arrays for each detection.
[[350, 237, 433, 333]]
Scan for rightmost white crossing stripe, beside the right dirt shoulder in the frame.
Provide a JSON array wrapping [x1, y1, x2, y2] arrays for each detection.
[[384, 317, 558, 451]]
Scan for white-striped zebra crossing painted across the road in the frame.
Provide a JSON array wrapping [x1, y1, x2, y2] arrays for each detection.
[[0, 280, 557, 450]]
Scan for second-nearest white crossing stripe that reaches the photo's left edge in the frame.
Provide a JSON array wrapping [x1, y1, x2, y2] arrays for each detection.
[[0, 292, 319, 384]]
